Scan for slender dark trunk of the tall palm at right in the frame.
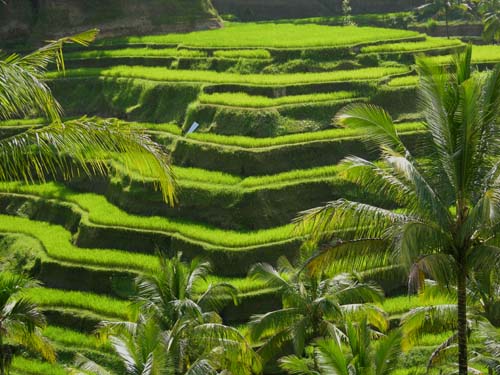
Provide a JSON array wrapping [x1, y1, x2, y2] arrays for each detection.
[[457, 251, 468, 375]]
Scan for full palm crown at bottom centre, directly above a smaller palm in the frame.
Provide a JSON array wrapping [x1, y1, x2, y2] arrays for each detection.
[[250, 259, 388, 362]]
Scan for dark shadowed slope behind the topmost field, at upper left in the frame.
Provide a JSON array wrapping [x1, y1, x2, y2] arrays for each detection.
[[0, 0, 220, 42]]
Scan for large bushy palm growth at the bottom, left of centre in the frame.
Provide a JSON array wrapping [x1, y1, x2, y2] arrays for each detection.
[[88, 253, 261, 375]]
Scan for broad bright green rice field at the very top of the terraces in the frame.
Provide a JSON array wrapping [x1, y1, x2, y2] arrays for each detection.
[[101, 23, 420, 48]]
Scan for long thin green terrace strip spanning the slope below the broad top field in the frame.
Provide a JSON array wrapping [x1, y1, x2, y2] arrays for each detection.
[[48, 65, 409, 86]]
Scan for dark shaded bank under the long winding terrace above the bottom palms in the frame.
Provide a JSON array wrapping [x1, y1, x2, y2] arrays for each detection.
[[0, 193, 301, 277]]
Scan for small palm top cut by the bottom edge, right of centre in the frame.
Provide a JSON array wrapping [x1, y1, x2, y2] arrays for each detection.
[[280, 320, 402, 375]]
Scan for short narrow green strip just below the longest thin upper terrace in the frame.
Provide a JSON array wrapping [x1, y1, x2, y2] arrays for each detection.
[[199, 91, 358, 108]]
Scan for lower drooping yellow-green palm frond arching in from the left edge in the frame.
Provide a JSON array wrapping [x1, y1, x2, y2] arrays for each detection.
[[0, 118, 176, 204]]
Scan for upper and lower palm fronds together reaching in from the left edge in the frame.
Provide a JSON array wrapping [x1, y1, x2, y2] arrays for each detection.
[[0, 30, 175, 204]]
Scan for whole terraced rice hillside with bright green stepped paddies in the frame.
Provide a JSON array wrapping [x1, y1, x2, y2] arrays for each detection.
[[0, 23, 500, 375]]
